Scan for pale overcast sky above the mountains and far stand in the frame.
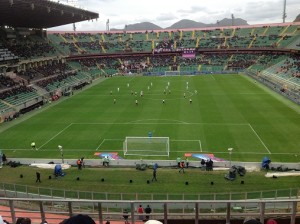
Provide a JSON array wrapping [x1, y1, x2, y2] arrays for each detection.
[[51, 0, 300, 31]]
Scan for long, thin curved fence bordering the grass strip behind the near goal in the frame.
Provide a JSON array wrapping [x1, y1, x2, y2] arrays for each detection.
[[0, 183, 299, 201]]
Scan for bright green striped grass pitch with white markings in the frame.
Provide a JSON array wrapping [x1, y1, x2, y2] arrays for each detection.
[[0, 75, 300, 162]]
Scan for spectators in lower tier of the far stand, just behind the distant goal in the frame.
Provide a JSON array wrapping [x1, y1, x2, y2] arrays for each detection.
[[72, 53, 286, 74]]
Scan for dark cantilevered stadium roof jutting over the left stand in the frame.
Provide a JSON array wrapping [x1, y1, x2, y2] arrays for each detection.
[[0, 0, 99, 28]]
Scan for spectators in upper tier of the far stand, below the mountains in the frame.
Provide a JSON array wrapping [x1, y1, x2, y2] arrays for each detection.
[[49, 24, 298, 54]]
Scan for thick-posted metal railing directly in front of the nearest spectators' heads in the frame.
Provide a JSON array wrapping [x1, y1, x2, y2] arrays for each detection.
[[0, 197, 300, 224]]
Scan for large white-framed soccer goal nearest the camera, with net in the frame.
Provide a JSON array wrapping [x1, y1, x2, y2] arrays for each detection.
[[123, 137, 170, 156]]
